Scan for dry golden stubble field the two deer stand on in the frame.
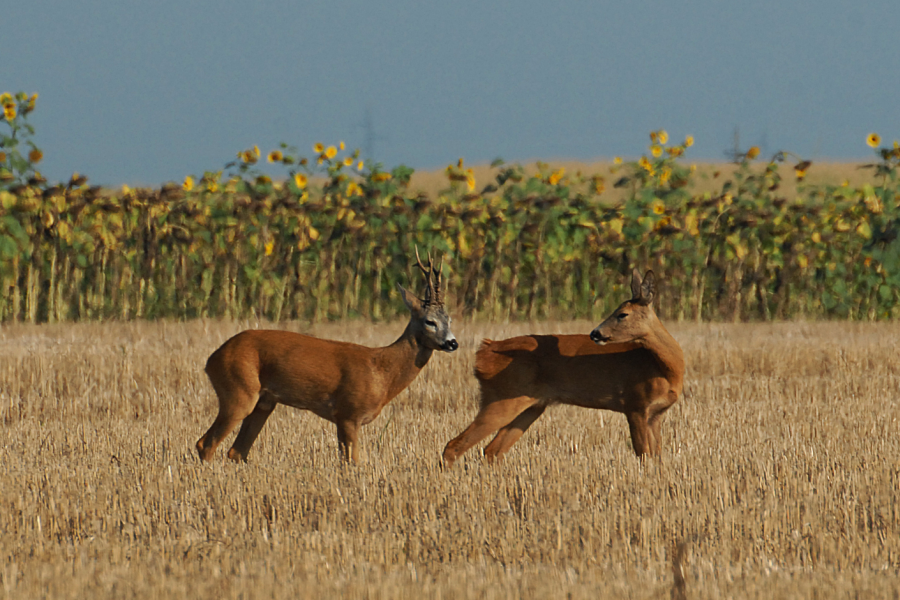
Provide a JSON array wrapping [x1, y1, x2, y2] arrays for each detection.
[[0, 321, 900, 599]]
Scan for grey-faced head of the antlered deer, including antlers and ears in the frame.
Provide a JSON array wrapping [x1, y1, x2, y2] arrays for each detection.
[[397, 247, 459, 352]]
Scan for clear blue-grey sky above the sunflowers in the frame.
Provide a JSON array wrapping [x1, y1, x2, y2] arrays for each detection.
[[7, 0, 900, 185]]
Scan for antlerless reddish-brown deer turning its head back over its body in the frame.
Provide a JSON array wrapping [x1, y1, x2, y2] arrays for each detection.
[[443, 270, 684, 467]]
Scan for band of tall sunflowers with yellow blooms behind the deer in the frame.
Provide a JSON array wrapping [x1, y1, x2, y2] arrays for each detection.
[[0, 93, 900, 322]]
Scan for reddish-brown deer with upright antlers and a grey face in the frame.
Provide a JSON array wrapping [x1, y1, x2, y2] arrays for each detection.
[[197, 249, 459, 462]]
